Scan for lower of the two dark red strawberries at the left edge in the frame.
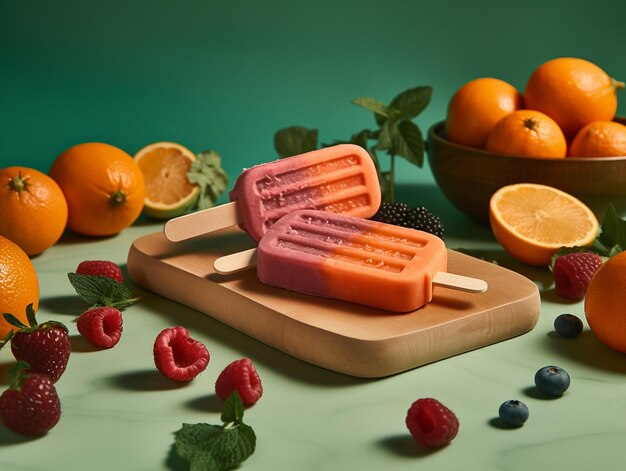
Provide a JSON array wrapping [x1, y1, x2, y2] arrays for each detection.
[[0, 362, 61, 436]]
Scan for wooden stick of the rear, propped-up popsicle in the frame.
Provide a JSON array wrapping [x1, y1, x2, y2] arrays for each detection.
[[163, 201, 243, 242]]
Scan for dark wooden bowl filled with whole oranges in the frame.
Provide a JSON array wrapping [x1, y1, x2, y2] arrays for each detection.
[[428, 58, 626, 224]]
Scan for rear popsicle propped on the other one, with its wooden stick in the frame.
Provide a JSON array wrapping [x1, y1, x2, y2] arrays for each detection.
[[163, 144, 381, 242]]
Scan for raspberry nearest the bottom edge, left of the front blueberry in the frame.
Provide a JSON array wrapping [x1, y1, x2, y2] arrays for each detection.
[[406, 398, 459, 448]]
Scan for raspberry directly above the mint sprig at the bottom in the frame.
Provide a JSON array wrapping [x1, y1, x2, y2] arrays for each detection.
[[215, 358, 263, 405]]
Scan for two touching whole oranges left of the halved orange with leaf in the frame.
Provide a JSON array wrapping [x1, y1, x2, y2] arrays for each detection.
[[0, 143, 145, 256]]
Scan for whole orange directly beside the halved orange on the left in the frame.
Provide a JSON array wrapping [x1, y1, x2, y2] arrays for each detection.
[[50, 142, 145, 236]]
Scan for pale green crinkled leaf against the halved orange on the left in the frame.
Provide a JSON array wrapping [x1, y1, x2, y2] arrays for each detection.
[[187, 150, 228, 210]]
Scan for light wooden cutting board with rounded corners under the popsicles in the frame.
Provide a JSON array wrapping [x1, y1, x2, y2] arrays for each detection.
[[128, 228, 540, 378]]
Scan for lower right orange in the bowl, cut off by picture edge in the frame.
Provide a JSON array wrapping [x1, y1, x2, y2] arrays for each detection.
[[569, 121, 626, 157]]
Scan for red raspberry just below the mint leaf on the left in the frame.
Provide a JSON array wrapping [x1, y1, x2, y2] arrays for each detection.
[[76, 307, 122, 348]]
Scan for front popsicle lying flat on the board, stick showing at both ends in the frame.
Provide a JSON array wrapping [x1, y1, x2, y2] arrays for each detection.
[[215, 210, 487, 312]]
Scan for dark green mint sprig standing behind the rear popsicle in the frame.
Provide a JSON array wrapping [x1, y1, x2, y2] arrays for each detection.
[[274, 86, 432, 201]]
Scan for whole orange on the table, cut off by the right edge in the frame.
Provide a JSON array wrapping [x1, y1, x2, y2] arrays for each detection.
[[585, 252, 626, 353]]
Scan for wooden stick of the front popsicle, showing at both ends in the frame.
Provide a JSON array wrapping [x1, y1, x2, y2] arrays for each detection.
[[213, 248, 487, 293]]
